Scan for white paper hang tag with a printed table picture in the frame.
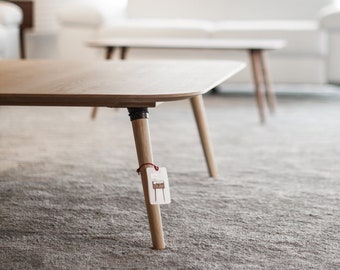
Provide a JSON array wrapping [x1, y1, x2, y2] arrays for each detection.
[[146, 167, 171, 204]]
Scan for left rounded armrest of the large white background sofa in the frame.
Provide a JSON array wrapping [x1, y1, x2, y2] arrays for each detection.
[[57, 1, 125, 27]]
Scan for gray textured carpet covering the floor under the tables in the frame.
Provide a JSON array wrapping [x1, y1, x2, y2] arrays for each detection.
[[0, 88, 340, 269]]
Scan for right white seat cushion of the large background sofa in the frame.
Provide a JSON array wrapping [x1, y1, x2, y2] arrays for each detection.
[[211, 21, 326, 55]]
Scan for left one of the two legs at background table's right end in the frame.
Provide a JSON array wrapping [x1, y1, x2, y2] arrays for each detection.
[[250, 50, 265, 123]]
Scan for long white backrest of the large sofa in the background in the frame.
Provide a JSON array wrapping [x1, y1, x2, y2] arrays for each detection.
[[127, 0, 333, 21]]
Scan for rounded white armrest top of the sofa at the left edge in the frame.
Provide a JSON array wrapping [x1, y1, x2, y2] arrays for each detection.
[[0, 1, 23, 26]]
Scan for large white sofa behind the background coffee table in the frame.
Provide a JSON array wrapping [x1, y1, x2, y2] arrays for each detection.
[[58, 0, 340, 83]]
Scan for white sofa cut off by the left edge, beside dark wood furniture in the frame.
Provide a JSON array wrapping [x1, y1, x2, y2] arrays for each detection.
[[0, 1, 23, 59]]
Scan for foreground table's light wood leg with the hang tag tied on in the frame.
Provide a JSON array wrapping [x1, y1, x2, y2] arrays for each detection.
[[128, 108, 165, 250]]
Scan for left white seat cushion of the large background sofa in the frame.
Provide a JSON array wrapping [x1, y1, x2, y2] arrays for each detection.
[[99, 19, 212, 38]]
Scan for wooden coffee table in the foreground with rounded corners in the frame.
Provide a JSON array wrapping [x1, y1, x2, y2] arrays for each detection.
[[0, 60, 244, 249]]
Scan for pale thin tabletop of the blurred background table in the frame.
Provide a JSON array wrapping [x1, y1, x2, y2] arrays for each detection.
[[86, 38, 285, 50]]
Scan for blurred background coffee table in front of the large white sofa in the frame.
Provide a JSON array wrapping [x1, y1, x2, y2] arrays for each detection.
[[86, 38, 285, 123]]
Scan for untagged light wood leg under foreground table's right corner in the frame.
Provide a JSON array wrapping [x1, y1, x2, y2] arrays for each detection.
[[190, 95, 218, 178]]
